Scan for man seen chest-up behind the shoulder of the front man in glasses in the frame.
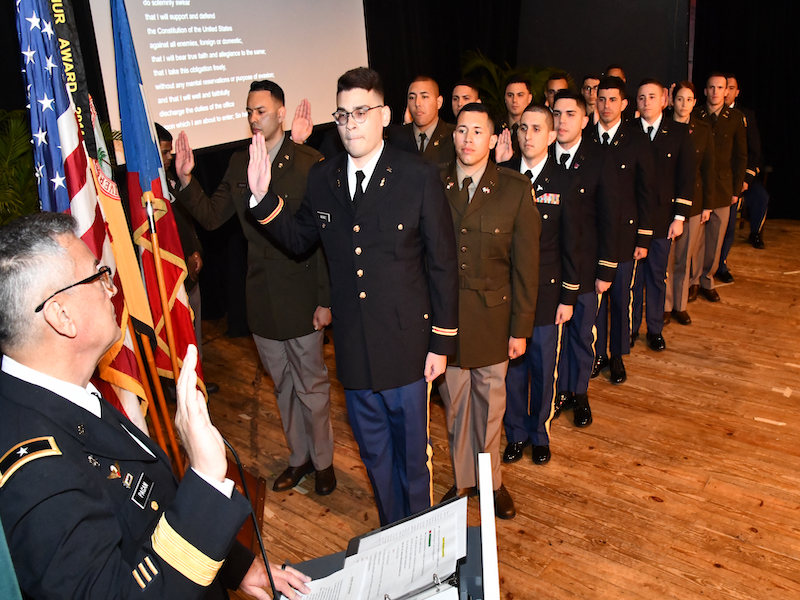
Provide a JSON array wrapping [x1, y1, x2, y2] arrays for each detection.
[[389, 75, 455, 165]]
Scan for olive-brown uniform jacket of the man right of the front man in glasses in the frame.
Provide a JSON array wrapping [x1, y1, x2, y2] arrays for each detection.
[[441, 161, 542, 369]]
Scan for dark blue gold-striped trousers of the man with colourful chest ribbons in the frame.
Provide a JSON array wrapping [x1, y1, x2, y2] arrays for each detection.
[[503, 325, 562, 446]]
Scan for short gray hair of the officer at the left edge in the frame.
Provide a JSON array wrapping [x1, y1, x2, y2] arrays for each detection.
[[0, 212, 77, 353]]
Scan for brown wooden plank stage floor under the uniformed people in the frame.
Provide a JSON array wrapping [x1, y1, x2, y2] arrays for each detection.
[[198, 221, 800, 600]]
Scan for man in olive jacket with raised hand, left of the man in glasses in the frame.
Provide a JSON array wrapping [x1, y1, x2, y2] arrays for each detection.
[[175, 81, 336, 496]]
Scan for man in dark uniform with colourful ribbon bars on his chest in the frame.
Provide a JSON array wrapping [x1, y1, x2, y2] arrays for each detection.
[[503, 104, 582, 465]]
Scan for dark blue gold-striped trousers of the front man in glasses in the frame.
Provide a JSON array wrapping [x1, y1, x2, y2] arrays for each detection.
[[344, 379, 433, 525]]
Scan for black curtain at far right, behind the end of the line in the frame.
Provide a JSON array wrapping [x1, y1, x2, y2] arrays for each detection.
[[692, 0, 800, 220]]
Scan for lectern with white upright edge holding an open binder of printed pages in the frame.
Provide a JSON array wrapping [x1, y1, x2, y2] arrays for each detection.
[[288, 454, 500, 600]]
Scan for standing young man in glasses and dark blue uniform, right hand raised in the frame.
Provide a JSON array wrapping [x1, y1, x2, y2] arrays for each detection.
[[248, 68, 458, 524]]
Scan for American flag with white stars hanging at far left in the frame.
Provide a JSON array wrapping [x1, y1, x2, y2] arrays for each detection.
[[16, 0, 152, 431]]
